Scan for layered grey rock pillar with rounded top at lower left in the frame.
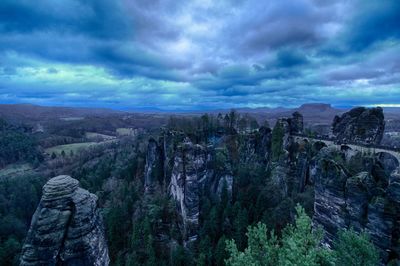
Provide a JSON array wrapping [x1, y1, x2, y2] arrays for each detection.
[[21, 175, 109, 266]]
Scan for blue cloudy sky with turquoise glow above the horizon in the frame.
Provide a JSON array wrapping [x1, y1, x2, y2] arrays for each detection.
[[0, 0, 400, 111]]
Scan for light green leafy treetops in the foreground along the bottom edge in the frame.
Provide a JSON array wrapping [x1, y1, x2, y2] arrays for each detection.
[[226, 206, 379, 266]]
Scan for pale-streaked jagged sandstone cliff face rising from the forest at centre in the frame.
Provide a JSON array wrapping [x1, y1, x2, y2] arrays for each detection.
[[144, 128, 271, 247]]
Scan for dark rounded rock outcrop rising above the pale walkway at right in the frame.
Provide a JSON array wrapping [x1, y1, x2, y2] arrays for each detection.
[[332, 107, 385, 145]]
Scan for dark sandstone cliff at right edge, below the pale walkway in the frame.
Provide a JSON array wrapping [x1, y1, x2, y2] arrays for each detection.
[[310, 148, 400, 262]]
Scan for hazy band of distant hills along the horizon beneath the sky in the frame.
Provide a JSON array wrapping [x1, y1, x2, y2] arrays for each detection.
[[0, 103, 400, 129]]
